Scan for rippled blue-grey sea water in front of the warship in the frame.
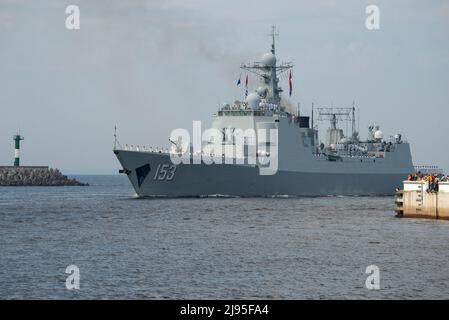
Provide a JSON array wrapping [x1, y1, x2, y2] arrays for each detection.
[[0, 176, 449, 299]]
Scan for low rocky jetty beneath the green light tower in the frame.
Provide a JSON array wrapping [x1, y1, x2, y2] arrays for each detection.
[[0, 167, 89, 186]]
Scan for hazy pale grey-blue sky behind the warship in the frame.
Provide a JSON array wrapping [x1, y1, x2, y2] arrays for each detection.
[[0, 0, 449, 173]]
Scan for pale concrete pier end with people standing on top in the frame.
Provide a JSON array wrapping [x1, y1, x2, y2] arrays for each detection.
[[395, 181, 449, 220]]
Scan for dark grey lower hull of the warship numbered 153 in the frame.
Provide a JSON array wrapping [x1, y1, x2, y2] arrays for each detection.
[[114, 150, 411, 197]]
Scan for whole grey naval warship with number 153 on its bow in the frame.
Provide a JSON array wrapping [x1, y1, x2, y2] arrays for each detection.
[[113, 29, 414, 197]]
